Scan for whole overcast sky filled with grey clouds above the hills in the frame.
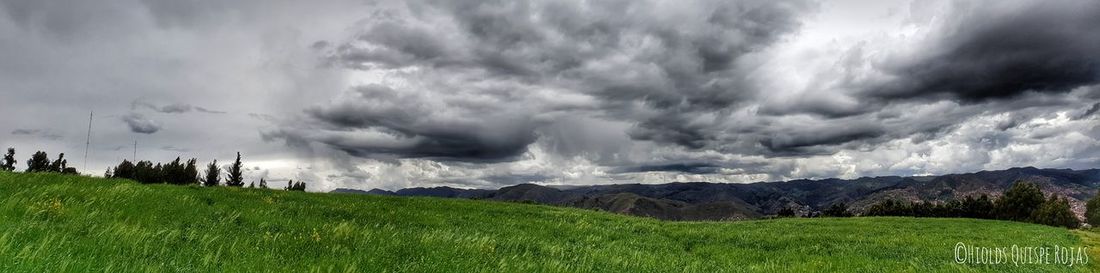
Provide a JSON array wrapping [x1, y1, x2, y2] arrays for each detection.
[[0, 0, 1100, 192]]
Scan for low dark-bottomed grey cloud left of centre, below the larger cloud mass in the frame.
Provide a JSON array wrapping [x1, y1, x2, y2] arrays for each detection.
[[267, 86, 536, 161]]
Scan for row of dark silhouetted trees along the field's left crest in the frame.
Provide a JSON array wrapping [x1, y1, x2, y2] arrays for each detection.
[[0, 148, 306, 192]]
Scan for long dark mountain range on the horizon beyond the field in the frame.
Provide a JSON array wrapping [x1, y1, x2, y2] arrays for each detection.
[[333, 167, 1100, 220]]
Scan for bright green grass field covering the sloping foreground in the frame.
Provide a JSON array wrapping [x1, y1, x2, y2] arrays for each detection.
[[0, 173, 1100, 272]]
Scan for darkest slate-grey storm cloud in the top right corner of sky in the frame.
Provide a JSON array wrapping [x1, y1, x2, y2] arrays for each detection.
[[867, 0, 1100, 101]]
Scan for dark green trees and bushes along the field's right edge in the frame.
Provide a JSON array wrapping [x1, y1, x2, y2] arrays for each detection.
[[778, 182, 1082, 228]]
